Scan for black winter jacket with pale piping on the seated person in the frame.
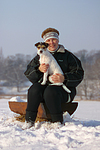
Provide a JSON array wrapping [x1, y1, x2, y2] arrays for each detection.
[[24, 45, 84, 95]]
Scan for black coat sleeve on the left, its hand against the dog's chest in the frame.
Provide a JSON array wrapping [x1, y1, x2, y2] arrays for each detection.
[[24, 55, 43, 83]]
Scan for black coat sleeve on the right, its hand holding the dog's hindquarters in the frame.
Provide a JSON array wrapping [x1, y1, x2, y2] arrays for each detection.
[[64, 53, 84, 87]]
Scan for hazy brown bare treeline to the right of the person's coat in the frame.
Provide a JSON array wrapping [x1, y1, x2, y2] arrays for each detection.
[[76, 50, 100, 99]]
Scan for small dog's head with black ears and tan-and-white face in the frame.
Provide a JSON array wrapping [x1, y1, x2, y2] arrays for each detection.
[[35, 42, 49, 55]]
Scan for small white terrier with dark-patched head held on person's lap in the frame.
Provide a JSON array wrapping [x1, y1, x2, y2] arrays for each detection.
[[35, 42, 71, 93]]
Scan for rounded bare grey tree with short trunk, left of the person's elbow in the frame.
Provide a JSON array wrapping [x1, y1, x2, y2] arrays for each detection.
[[5, 54, 26, 92]]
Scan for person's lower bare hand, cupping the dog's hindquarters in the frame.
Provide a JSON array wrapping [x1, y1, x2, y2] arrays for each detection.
[[51, 73, 65, 83]]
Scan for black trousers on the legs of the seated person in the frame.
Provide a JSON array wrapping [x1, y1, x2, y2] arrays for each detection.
[[25, 83, 75, 123]]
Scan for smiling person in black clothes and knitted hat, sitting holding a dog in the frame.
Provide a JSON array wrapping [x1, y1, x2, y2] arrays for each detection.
[[24, 28, 84, 129]]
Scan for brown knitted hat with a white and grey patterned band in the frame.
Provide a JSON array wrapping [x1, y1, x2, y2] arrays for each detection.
[[41, 28, 59, 41]]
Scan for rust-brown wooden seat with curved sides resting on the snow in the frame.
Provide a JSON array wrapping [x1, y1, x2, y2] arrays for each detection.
[[9, 101, 78, 120]]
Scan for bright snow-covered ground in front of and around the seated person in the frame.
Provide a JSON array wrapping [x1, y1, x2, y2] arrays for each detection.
[[0, 99, 100, 150]]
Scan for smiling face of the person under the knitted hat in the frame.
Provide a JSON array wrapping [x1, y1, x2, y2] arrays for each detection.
[[46, 38, 59, 51]]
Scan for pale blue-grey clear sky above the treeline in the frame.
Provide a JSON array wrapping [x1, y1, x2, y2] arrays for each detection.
[[0, 0, 100, 57]]
